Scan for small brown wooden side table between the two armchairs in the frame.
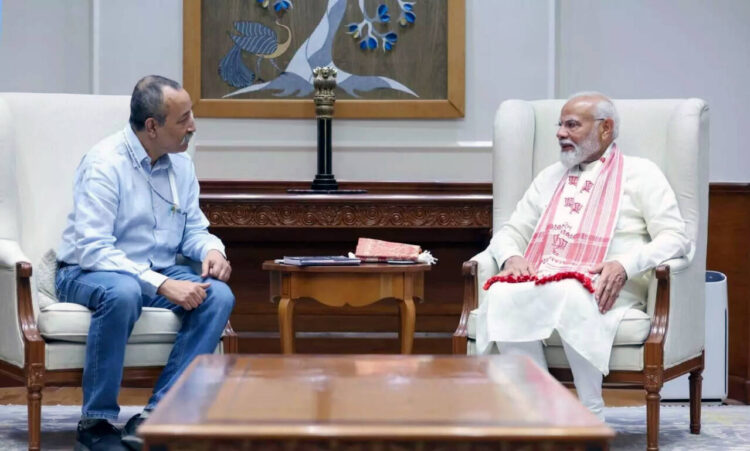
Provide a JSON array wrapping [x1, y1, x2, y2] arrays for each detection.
[[263, 261, 430, 354]]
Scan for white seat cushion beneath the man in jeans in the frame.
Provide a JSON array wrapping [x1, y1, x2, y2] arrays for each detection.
[[37, 302, 182, 343]]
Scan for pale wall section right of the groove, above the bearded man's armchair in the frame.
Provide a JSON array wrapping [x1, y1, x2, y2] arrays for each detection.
[[558, 0, 750, 182]]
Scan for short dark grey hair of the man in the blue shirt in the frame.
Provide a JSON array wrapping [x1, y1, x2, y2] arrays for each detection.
[[130, 75, 182, 131]]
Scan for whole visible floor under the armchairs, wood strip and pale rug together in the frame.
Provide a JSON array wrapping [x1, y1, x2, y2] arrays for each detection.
[[0, 387, 750, 451]]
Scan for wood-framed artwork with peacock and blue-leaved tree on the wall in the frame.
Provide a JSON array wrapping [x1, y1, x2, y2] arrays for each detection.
[[183, 0, 466, 118]]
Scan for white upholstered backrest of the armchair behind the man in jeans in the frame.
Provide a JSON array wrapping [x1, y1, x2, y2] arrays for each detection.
[[0, 93, 198, 264]]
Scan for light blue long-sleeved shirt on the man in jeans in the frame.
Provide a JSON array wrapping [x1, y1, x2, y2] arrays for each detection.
[[57, 125, 226, 296]]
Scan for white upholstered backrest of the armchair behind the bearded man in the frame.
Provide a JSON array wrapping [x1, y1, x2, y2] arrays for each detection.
[[493, 99, 708, 364]]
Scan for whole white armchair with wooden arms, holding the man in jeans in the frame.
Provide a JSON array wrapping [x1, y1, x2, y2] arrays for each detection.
[[0, 93, 237, 449]]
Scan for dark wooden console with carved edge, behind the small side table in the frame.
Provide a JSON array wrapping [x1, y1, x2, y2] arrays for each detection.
[[200, 180, 492, 354]]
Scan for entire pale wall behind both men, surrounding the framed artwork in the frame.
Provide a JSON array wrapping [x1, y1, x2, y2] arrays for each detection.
[[0, 0, 750, 182]]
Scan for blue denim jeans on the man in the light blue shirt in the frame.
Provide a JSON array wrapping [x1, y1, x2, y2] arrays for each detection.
[[55, 265, 234, 420]]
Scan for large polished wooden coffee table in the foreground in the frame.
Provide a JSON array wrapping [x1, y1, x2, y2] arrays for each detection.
[[139, 355, 614, 450]]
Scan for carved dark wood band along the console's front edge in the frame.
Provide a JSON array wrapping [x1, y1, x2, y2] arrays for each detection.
[[201, 201, 492, 228]]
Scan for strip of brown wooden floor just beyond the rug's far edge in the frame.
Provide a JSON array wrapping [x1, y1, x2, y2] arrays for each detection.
[[0, 387, 646, 407]]
